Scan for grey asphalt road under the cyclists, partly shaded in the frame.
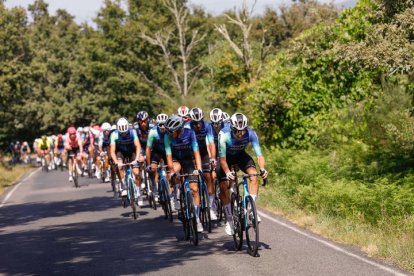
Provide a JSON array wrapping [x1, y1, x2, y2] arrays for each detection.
[[0, 170, 407, 276]]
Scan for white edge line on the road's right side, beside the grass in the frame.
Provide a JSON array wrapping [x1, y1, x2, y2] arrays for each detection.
[[258, 211, 407, 275]]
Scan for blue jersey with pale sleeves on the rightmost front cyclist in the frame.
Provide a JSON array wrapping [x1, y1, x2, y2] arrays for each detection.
[[219, 126, 262, 157]]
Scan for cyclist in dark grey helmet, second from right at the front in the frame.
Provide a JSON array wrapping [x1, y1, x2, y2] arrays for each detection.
[[164, 115, 203, 232]]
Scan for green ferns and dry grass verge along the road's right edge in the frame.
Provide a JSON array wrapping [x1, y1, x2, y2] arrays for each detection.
[[258, 150, 414, 272]]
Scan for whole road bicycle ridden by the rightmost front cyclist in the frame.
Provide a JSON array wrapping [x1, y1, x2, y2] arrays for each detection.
[[229, 167, 266, 256]]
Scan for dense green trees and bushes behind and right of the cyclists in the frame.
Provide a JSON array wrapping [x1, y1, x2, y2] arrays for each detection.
[[0, 0, 414, 270]]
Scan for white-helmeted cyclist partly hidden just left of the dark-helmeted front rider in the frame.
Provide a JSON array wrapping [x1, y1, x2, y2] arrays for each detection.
[[145, 113, 168, 203]]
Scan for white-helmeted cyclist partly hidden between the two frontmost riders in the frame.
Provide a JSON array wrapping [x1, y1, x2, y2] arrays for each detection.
[[190, 107, 217, 220]]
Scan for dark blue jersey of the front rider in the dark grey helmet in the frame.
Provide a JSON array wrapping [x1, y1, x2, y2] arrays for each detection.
[[164, 128, 198, 159]]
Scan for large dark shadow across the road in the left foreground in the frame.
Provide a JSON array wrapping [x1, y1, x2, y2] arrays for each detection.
[[0, 215, 234, 275]]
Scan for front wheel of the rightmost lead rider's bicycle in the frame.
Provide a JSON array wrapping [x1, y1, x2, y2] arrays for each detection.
[[244, 195, 260, 257]]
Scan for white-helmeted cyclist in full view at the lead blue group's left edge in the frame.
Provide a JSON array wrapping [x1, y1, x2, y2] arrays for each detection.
[[110, 117, 143, 203]]
